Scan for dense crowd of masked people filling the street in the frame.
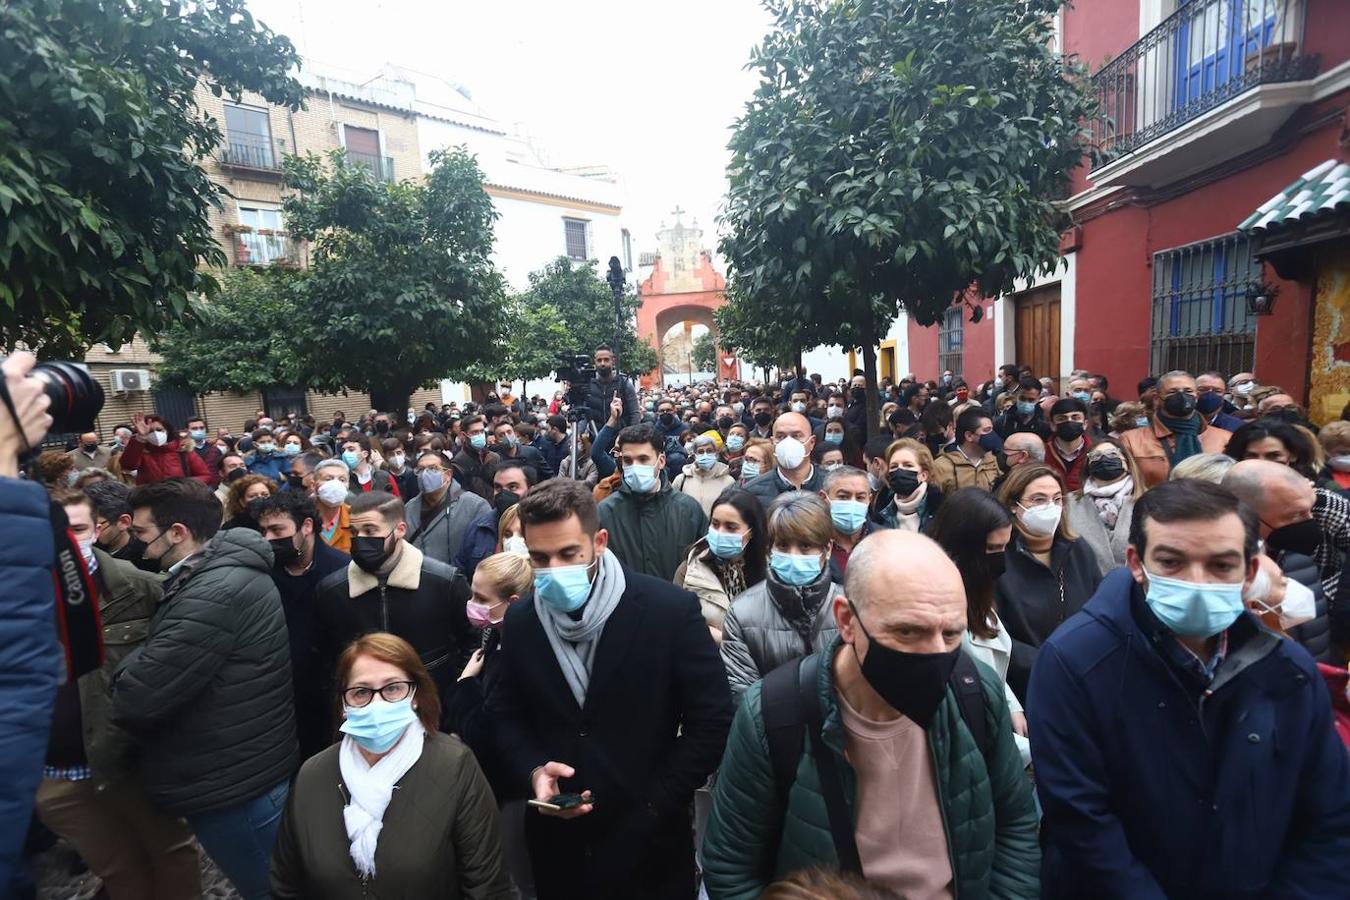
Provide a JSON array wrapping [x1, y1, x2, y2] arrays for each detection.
[[10, 347, 1350, 900]]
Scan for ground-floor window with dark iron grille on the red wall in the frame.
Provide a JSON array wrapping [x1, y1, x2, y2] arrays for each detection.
[[1150, 233, 1261, 375]]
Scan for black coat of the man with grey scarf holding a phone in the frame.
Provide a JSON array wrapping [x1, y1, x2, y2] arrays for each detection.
[[491, 567, 732, 900]]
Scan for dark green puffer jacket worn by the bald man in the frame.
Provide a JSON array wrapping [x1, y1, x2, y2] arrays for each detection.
[[703, 637, 1041, 900]]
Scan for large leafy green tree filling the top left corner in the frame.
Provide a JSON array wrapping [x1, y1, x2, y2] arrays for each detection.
[[0, 0, 304, 358]]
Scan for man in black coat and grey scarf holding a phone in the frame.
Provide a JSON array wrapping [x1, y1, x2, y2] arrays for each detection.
[[491, 479, 732, 900]]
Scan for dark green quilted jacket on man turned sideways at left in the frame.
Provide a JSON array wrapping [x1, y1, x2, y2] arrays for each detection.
[[112, 528, 297, 815]]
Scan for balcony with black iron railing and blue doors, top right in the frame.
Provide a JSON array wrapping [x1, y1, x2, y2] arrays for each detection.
[[1091, 0, 1318, 186]]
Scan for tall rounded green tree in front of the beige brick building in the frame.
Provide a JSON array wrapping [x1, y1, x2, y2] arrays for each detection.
[[284, 148, 509, 410]]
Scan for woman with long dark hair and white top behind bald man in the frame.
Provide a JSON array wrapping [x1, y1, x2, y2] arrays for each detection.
[[929, 487, 1031, 765]]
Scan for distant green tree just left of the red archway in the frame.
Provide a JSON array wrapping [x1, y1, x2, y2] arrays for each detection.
[[521, 256, 657, 375]]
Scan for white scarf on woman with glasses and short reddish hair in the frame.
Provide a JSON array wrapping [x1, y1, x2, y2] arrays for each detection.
[[338, 719, 427, 877]]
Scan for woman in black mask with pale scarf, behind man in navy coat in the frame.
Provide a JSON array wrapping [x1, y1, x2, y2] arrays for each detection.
[[1065, 437, 1143, 575]]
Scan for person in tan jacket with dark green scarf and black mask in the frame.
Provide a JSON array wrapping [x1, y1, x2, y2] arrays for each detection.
[[1121, 371, 1233, 488]]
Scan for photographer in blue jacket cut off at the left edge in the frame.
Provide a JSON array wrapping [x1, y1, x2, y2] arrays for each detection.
[[0, 354, 62, 896]]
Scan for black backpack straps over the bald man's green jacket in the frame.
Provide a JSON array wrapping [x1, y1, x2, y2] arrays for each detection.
[[760, 653, 992, 874]]
